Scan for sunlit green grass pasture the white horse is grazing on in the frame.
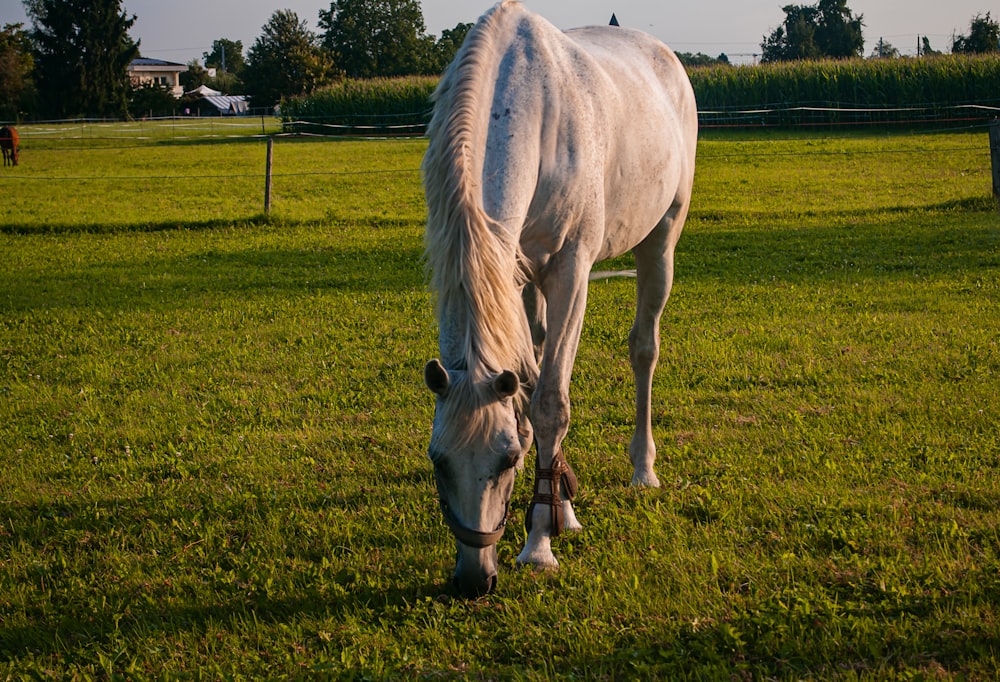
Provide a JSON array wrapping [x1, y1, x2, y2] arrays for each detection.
[[0, 124, 1000, 680]]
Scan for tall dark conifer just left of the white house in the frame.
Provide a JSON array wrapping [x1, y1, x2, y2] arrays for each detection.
[[24, 0, 139, 118]]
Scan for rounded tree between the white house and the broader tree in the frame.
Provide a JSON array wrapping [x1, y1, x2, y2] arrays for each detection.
[[243, 10, 333, 106]]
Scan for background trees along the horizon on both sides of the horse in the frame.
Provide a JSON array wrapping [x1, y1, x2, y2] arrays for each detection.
[[0, 0, 1000, 120]]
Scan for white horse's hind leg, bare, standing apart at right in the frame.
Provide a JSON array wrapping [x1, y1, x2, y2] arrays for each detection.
[[628, 206, 687, 488]]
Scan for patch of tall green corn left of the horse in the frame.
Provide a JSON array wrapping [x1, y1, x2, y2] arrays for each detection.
[[281, 76, 438, 134]]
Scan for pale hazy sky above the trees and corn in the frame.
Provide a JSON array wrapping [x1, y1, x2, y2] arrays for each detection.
[[0, 0, 1000, 63]]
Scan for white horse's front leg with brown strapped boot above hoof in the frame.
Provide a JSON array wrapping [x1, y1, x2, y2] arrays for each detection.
[[517, 264, 589, 567]]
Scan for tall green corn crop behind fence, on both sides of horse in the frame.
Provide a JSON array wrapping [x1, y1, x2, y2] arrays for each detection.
[[281, 55, 1000, 135]]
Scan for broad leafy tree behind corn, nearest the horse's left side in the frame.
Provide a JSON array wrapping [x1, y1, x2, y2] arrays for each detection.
[[319, 0, 438, 78]]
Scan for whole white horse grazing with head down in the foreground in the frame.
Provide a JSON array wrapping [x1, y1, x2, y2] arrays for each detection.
[[422, 0, 698, 596]]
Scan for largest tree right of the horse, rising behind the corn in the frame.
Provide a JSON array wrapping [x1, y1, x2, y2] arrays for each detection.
[[760, 0, 865, 62]]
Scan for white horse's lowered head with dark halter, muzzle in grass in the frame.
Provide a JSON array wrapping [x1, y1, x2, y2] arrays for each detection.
[[424, 360, 532, 597]]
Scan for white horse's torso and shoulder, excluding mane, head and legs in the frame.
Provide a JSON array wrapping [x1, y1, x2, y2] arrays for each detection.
[[482, 12, 697, 263]]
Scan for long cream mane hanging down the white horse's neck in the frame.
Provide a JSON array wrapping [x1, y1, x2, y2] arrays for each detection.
[[422, 0, 530, 374]]
